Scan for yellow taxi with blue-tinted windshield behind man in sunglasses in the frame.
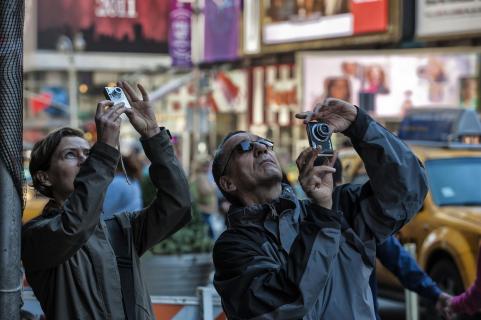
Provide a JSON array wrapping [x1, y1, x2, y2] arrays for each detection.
[[339, 109, 481, 294]]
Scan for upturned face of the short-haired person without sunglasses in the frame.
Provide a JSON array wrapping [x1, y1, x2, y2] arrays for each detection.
[[45, 136, 90, 201]]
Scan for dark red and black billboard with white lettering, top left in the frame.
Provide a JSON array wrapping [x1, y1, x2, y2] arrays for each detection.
[[37, 0, 169, 53]]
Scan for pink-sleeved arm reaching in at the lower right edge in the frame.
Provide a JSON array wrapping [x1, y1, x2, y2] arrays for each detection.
[[443, 248, 481, 320]]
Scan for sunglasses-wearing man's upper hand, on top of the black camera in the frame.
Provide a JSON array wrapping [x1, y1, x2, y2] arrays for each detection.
[[296, 98, 357, 132]]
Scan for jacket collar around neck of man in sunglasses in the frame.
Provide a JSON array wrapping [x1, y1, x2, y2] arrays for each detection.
[[227, 184, 298, 228]]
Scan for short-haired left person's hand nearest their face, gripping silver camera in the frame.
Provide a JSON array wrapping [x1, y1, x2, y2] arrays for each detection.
[[95, 100, 127, 148]]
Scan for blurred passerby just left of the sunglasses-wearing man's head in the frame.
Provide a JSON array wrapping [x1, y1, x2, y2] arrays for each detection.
[[191, 157, 218, 239]]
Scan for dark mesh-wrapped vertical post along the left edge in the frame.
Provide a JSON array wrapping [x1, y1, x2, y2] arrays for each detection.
[[0, 0, 25, 320]]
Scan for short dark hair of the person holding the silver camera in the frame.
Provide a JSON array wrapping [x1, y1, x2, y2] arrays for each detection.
[[29, 127, 84, 198]]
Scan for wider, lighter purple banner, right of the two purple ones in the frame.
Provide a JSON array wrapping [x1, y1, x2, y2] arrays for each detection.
[[204, 0, 241, 62]]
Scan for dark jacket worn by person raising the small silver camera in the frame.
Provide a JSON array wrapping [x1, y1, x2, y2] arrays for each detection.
[[22, 130, 191, 320]]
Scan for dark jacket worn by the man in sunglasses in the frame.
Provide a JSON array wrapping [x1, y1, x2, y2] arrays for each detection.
[[214, 110, 427, 320]]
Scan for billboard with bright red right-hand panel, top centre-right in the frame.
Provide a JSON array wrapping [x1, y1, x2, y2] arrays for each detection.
[[248, 0, 403, 54]]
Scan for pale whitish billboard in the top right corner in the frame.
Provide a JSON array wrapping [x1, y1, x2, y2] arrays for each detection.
[[416, 0, 481, 38]]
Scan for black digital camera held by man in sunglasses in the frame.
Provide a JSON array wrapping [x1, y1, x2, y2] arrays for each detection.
[[306, 122, 334, 166]]
